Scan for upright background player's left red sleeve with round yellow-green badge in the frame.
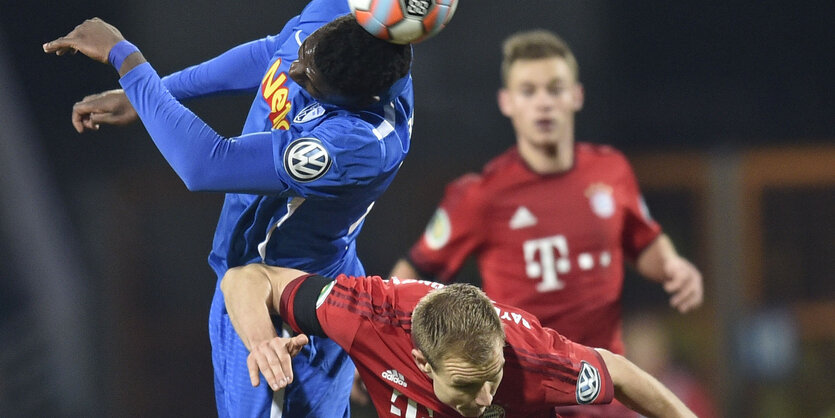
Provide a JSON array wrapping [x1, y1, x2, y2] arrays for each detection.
[[409, 174, 485, 281]]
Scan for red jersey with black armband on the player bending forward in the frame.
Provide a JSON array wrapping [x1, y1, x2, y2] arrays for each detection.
[[280, 275, 614, 418]]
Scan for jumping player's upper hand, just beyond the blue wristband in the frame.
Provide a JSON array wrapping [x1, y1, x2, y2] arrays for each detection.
[[43, 17, 125, 64]]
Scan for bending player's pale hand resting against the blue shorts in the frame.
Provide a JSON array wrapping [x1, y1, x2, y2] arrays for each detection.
[[246, 334, 309, 391]]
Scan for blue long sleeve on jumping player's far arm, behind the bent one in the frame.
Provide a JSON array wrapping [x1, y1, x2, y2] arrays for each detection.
[[162, 16, 299, 100]]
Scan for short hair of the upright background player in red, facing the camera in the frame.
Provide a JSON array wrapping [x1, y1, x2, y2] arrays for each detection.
[[502, 29, 580, 87]]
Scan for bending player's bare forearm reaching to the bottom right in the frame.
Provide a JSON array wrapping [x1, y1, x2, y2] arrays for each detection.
[[596, 348, 696, 418]]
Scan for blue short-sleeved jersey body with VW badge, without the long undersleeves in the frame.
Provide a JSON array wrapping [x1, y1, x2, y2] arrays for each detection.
[[209, 29, 413, 277]]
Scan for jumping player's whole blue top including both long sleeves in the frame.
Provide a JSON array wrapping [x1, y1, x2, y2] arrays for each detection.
[[121, 0, 413, 278]]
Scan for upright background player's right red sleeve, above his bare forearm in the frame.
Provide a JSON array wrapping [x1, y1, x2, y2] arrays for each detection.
[[621, 156, 661, 261]]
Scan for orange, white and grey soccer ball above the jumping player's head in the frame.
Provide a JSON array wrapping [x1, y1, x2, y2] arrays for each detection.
[[348, 0, 458, 44]]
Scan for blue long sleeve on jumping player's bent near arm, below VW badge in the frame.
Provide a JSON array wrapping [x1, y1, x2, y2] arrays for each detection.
[[119, 63, 289, 194]]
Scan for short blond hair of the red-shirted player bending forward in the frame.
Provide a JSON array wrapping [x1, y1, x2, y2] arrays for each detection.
[[412, 283, 504, 369]]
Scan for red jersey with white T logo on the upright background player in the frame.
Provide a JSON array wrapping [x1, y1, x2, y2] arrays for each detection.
[[409, 143, 661, 354]]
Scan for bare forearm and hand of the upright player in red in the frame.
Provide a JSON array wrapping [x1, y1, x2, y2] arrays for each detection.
[[635, 234, 704, 313]]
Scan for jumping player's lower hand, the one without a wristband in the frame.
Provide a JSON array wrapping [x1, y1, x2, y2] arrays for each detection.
[[72, 89, 139, 133]]
